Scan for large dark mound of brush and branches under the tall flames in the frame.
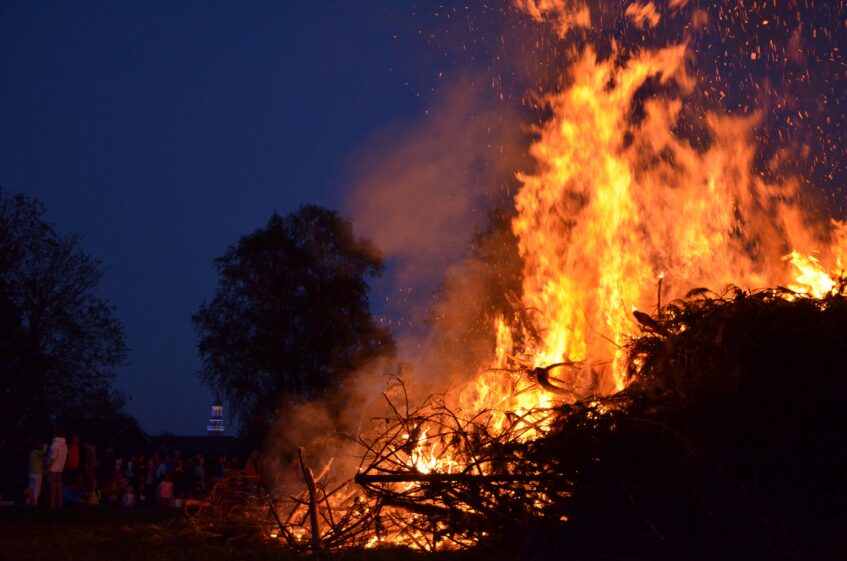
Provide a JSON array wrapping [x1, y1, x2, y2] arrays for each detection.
[[189, 281, 847, 559]]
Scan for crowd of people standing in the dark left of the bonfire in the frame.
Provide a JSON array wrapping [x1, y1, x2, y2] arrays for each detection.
[[24, 432, 257, 509]]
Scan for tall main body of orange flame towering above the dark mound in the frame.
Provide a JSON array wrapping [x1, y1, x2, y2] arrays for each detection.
[[500, 41, 840, 393]]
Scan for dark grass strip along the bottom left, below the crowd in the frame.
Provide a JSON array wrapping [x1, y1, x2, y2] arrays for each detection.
[[0, 507, 473, 561]]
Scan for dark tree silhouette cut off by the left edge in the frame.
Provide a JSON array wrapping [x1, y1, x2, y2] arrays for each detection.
[[0, 188, 128, 442]]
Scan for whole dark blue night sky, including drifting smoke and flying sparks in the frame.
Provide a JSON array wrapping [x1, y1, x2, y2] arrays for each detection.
[[0, 0, 847, 434]]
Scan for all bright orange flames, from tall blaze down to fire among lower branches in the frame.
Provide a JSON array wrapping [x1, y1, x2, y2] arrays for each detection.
[[364, 37, 847, 549]]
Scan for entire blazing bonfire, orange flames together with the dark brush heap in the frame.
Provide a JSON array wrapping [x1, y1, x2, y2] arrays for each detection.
[[187, 1, 847, 558]]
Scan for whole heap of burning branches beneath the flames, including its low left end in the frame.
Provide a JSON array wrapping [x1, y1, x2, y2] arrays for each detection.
[[189, 281, 847, 553]]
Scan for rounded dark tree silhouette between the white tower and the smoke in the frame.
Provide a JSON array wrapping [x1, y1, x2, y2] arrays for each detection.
[[193, 205, 394, 437]]
